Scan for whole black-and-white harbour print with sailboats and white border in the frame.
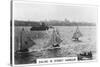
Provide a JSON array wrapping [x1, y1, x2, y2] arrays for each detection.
[[11, 0, 97, 65]]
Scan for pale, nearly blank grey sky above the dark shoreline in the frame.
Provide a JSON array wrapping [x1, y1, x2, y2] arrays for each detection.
[[13, 2, 97, 23]]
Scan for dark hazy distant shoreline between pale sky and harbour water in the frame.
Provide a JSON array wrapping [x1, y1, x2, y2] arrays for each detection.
[[14, 20, 96, 26]]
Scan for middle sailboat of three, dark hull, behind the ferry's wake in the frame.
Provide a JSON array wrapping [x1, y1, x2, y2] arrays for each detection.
[[48, 29, 63, 49]]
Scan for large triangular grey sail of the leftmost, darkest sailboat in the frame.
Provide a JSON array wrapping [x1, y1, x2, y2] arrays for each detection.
[[19, 28, 34, 50]]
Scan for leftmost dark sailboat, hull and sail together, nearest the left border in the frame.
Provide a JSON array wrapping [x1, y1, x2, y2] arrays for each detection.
[[16, 28, 33, 53]]
